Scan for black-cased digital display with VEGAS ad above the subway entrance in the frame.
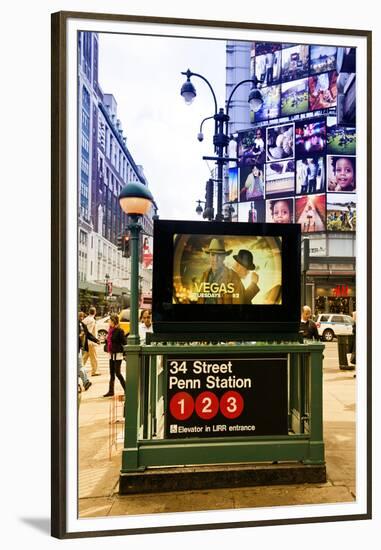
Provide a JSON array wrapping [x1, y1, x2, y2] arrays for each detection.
[[152, 220, 301, 338]]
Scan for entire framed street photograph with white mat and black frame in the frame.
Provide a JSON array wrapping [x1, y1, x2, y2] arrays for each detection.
[[52, 12, 372, 538]]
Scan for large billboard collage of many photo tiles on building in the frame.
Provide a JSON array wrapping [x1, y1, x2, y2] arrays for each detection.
[[229, 42, 356, 233]]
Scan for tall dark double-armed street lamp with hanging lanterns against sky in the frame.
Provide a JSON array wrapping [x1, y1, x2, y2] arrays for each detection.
[[180, 69, 263, 221]]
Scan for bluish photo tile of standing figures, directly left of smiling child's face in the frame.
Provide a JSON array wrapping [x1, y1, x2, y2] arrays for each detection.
[[295, 156, 326, 195]]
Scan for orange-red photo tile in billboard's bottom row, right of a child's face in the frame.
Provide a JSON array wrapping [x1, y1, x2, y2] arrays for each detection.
[[295, 193, 326, 233]]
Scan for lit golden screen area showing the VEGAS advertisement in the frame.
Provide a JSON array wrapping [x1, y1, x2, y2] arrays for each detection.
[[172, 234, 282, 304]]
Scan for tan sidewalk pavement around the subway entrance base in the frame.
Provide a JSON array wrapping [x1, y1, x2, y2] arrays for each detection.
[[79, 342, 356, 518]]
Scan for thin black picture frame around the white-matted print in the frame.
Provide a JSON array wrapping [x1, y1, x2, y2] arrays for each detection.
[[51, 11, 372, 539]]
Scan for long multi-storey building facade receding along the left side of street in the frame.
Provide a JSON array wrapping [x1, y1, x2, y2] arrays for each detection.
[[78, 32, 154, 314]]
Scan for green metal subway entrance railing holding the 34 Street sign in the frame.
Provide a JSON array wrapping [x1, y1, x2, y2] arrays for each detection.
[[121, 341, 324, 475]]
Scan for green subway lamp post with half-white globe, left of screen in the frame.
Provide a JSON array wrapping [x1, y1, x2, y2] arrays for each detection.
[[119, 182, 154, 345]]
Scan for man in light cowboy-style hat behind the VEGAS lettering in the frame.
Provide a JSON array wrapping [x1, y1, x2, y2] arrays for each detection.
[[197, 238, 245, 304]]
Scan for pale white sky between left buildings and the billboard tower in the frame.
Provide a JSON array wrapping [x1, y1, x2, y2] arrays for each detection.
[[99, 33, 226, 220]]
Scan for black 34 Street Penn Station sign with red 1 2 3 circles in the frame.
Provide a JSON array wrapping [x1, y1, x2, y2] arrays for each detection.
[[165, 354, 288, 439]]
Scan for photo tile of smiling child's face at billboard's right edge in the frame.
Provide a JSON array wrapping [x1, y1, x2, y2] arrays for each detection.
[[327, 155, 356, 193]]
